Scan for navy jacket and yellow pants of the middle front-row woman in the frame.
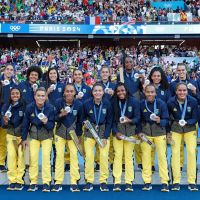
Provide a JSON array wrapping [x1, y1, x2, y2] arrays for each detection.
[[83, 98, 113, 191]]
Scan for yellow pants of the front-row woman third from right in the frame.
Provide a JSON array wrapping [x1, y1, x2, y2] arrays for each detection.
[[113, 136, 135, 184]]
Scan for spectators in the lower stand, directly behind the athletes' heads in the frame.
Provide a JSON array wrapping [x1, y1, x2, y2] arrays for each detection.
[[0, 46, 200, 85]]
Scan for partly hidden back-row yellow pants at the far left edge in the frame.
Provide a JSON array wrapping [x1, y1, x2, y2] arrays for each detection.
[[0, 127, 7, 166]]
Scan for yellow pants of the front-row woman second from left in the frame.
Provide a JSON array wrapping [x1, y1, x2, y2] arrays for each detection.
[[29, 139, 52, 185]]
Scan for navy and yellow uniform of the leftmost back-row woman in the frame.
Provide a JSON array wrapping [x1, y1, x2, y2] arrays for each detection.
[[0, 75, 16, 171]]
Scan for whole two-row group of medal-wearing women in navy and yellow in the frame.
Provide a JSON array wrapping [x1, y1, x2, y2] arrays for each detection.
[[0, 57, 200, 192]]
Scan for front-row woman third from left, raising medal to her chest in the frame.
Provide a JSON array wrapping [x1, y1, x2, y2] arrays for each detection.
[[52, 83, 83, 192]]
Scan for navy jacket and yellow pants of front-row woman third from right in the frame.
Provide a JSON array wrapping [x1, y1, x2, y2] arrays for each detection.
[[112, 97, 140, 191]]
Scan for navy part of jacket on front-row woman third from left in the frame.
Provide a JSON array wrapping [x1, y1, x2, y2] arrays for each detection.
[[55, 98, 83, 136]]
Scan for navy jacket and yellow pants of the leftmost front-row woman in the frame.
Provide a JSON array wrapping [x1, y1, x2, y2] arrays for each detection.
[[1, 101, 25, 190]]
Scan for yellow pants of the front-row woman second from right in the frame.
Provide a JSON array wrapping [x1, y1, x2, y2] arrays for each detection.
[[141, 135, 169, 184]]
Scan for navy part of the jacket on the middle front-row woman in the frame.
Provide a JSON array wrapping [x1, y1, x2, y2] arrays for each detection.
[[83, 97, 113, 139]]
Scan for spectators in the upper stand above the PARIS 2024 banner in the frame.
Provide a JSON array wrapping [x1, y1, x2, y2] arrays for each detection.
[[0, 0, 200, 23]]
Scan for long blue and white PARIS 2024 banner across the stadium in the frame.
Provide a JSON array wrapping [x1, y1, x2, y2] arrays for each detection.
[[1, 23, 200, 35]]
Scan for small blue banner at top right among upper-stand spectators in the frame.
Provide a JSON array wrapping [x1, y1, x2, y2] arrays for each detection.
[[151, 1, 184, 10]]
